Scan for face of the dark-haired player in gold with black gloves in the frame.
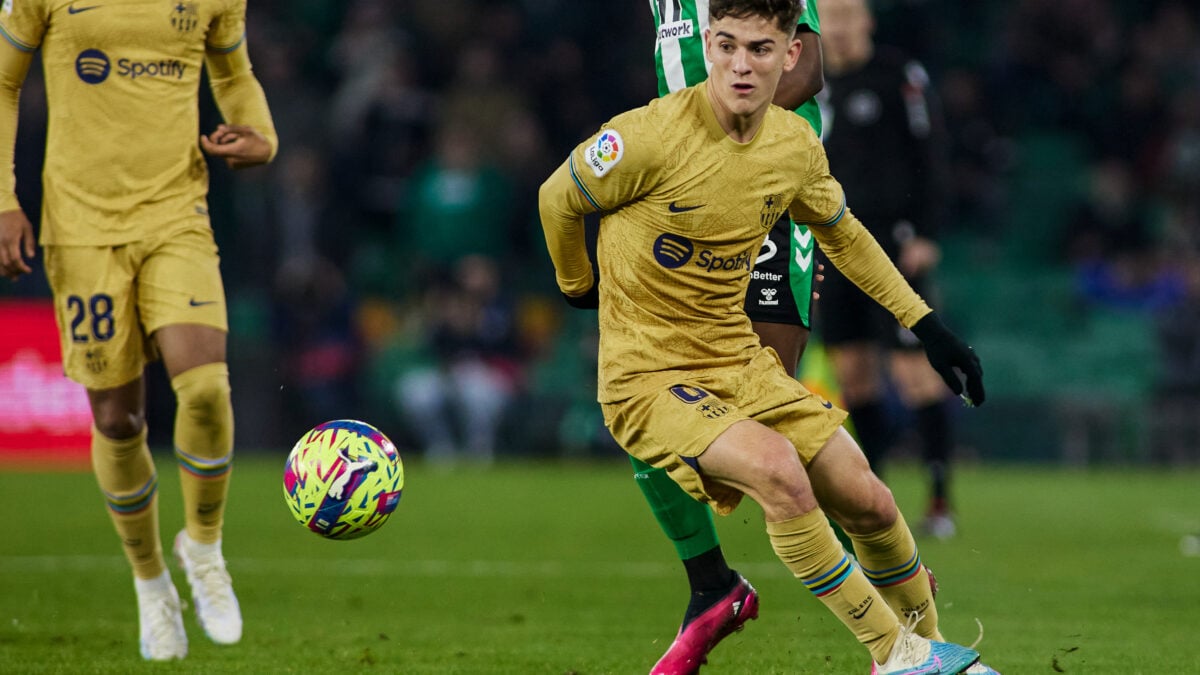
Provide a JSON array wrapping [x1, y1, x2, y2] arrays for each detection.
[[704, 17, 800, 123]]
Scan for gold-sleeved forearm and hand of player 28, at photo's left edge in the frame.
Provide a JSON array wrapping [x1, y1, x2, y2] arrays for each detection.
[[0, 40, 36, 280]]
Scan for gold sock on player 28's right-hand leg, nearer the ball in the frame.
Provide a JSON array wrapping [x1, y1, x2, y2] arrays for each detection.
[[170, 363, 233, 544]]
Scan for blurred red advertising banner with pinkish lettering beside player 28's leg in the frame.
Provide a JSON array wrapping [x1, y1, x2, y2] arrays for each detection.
[[0, 299, 91, 468]]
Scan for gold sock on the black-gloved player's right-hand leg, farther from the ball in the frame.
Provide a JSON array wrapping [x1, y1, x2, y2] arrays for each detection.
[[850, 514, 944, 641]]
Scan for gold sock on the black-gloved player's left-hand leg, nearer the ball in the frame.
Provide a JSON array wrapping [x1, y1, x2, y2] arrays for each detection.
[[767, 508, 900, 663]]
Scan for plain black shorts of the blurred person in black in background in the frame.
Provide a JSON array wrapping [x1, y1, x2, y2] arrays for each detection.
[[817, 249, 932, 350]]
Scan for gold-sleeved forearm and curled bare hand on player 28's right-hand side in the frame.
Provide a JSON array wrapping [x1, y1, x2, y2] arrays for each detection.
[[207, 40, 278, 169]]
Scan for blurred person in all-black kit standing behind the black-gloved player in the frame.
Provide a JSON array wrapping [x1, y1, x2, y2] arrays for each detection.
[[820, 0, 954, 537]]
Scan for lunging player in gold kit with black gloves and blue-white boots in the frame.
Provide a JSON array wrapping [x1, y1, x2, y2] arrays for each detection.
[[540, 0, 984, 675]]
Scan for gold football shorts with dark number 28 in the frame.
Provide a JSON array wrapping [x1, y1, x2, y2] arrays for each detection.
[[46, 220, 229, 389]]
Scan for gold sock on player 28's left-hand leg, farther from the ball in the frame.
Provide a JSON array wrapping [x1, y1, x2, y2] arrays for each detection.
[[91, 426, 167, 579]]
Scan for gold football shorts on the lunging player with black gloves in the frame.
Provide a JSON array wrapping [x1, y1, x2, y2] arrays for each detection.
[[601, 350, 846, 515]]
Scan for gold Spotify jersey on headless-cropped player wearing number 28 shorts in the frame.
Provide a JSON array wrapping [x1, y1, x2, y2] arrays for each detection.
[[0, 0, 246, 245]]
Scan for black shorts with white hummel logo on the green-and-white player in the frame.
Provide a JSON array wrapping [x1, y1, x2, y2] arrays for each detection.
[[745, 215, 816, 328]]
